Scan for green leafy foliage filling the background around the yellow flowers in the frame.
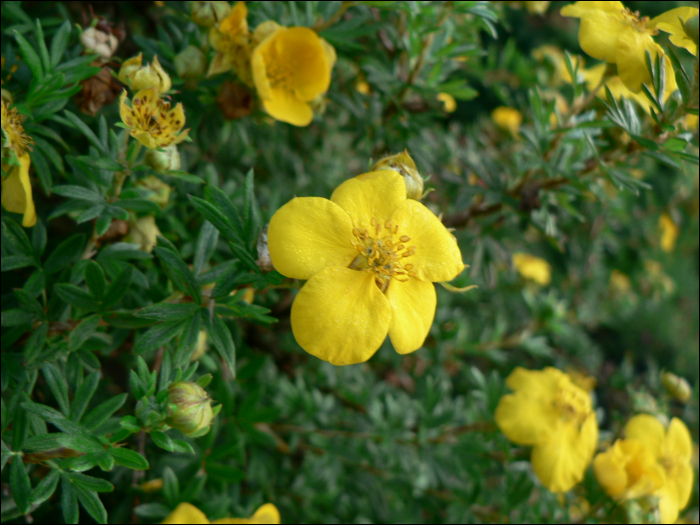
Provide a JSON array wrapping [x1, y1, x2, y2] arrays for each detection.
[[1, 2, 699, 523]]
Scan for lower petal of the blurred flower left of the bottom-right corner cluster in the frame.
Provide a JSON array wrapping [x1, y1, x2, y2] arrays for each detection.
[[531, 413, 598, 492]]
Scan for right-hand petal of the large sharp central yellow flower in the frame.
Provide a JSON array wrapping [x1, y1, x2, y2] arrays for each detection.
[[391, 199, 464, 282]]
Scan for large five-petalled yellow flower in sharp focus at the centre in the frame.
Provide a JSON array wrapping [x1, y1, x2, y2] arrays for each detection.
[[267, 171, 464, 365]]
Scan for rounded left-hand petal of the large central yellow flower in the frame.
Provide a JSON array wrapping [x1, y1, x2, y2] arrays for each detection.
[[267, 197, 357, 279]]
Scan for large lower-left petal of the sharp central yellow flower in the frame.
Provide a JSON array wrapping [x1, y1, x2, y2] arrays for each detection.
[[288, 266, 391, 365]]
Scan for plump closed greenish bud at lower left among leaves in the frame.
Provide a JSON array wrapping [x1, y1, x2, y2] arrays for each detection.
[[165, 381, 214, 436]]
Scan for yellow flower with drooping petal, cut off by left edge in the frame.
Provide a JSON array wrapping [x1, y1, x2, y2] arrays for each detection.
[[2, 99, 36, 228]]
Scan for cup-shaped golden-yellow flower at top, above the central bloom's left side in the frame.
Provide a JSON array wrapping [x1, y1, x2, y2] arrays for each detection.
[[251, 27, 336, 126]]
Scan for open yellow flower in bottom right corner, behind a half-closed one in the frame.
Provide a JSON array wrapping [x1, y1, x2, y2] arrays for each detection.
[[625, 414, 693, 523]]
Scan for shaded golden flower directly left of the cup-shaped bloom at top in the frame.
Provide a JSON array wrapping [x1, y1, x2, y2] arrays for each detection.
[[207, 2, 251, 80]]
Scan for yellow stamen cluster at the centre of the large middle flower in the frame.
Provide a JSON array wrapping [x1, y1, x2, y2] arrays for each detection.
[[349, 217, 416, 292]]
